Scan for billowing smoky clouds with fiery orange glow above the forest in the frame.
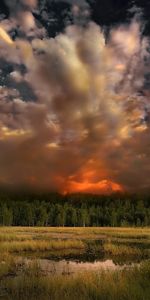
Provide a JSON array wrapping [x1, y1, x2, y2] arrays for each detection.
[[0, 0, 150, 194]]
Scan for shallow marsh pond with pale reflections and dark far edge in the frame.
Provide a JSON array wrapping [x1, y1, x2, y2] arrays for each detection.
[[11, 240, 149, 275]]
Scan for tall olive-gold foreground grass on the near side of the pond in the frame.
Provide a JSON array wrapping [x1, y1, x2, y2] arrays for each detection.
[[0, 262, 150, 300]]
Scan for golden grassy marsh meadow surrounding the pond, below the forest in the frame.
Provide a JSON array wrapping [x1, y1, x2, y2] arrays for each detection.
[[0, 227, 150, 300]]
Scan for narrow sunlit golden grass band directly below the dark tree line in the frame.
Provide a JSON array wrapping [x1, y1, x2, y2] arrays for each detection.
[[0, 227, 150, 243]]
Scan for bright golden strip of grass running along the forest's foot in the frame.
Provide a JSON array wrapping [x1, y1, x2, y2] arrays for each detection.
[[0, 227, 150, 239]]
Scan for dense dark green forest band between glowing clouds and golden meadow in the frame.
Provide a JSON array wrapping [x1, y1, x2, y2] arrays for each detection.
[[0, 191, 150, 227]]
